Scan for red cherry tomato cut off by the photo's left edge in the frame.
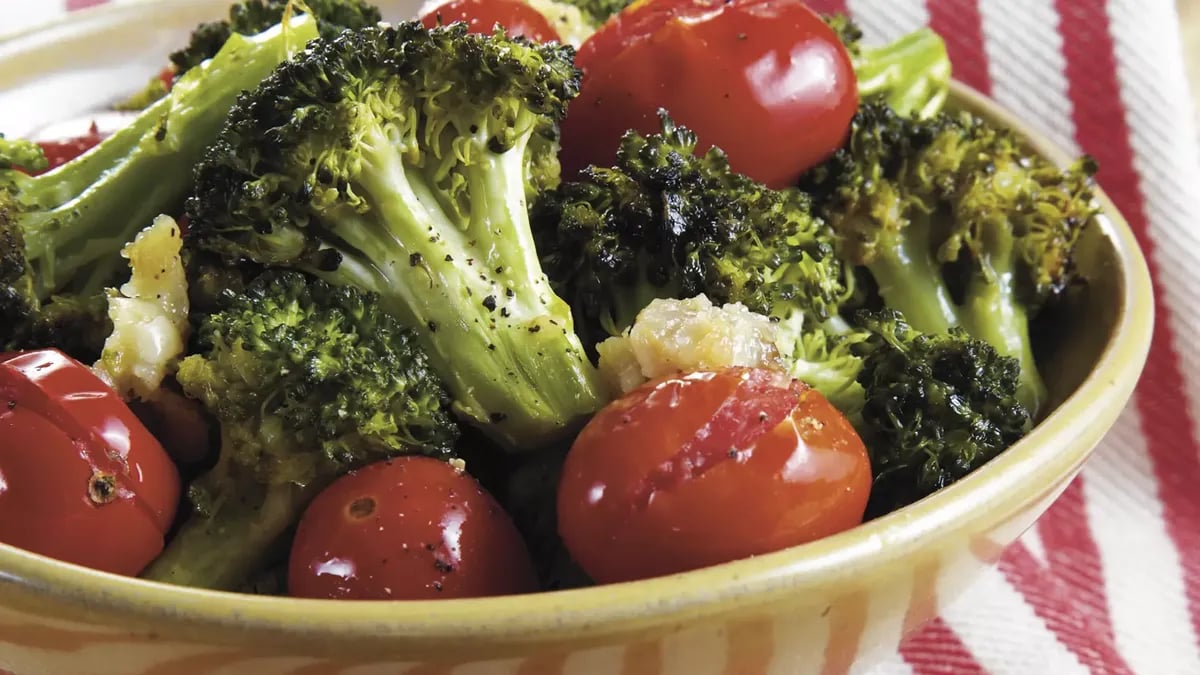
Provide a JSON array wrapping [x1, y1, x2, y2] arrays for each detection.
[[0, 350, 180, 575]]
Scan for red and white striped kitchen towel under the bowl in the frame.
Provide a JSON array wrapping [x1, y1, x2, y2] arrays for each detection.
[[7, 0, 1200, 675]]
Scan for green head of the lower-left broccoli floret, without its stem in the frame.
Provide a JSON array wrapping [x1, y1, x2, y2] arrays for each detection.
[[176, 267, 457, 494]]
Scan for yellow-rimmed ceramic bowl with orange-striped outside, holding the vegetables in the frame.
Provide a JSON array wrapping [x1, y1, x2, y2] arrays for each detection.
[[0, 0, 1153, 675]]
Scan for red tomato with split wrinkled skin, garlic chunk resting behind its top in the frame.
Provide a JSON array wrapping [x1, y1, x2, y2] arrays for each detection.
[[558, 368, 871, 584]]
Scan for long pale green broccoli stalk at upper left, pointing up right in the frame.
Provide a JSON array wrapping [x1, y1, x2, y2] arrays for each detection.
[[22, 14, 317, 298]]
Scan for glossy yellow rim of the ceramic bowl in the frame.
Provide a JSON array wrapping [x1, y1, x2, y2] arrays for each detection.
[[0, 0, 1154, 645]]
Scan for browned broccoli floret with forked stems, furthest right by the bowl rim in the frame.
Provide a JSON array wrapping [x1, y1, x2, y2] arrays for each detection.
[[802, 103, 1099, 414]]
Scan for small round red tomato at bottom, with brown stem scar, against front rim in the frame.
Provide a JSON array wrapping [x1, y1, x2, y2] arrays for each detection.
[[288, 456, 536, 599]]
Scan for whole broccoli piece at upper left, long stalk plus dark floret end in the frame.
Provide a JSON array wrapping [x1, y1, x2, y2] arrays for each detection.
[[0, 17, 317, 362]]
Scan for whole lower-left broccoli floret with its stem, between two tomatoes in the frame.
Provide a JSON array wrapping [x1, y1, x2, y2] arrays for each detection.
[[143, 271, 457, 590]]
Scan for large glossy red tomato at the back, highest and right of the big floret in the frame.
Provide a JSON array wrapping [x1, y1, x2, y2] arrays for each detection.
[[562, 0, 858, 187]]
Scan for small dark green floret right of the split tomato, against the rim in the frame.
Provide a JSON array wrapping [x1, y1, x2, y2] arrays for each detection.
[[853, 312, 1031, 515]]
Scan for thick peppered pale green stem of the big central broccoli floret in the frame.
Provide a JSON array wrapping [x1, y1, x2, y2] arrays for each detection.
[[322, 120, 601, 449]]
